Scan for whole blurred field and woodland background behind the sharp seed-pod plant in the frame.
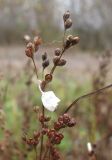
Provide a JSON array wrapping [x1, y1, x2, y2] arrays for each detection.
[[0, 0, 112, 160]]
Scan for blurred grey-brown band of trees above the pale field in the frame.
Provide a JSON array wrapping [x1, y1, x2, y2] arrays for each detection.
[[0, 0, 112, 49]]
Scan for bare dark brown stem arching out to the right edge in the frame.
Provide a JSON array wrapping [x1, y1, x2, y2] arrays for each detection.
[[64, 84, 112, 113]]
